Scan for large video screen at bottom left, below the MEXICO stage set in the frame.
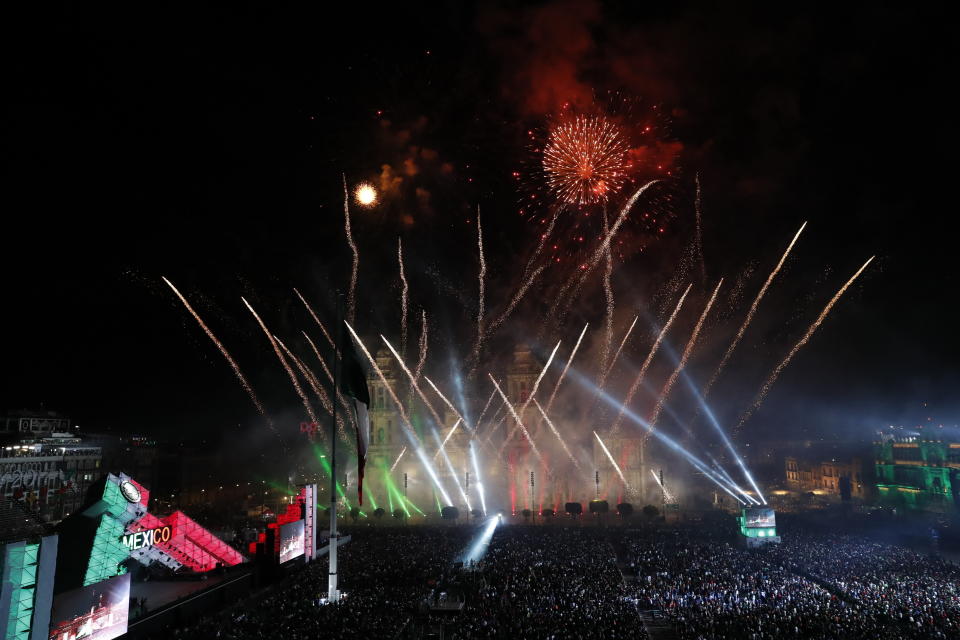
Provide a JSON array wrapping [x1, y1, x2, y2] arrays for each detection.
[[50, 573, 130, 640]]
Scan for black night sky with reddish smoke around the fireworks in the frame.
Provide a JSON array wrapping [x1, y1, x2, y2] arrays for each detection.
[[0, 2, 960, 452]]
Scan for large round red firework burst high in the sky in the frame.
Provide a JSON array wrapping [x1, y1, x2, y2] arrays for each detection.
[[543, 116, 629, 205]]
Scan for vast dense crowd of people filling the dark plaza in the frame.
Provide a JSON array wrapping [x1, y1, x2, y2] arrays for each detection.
[[146, 522, 960, 640]]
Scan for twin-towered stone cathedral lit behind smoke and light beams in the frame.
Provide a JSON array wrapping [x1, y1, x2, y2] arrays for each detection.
[[364, 347, 652, 516]]
